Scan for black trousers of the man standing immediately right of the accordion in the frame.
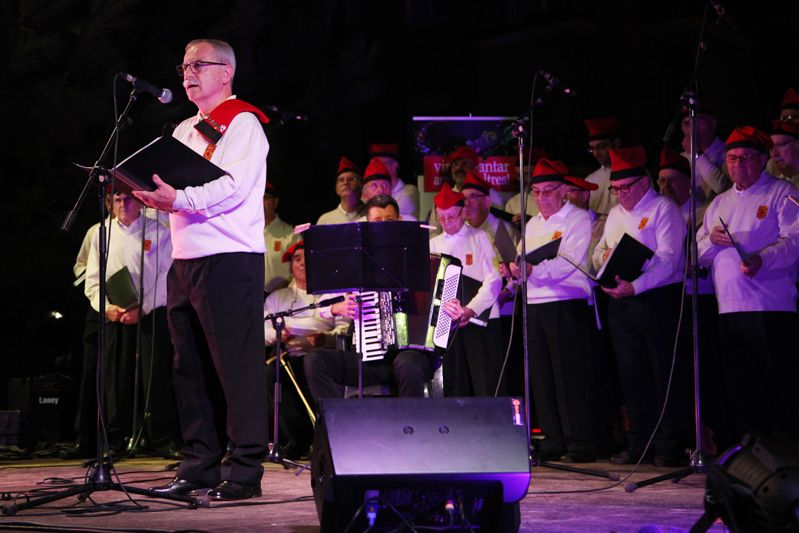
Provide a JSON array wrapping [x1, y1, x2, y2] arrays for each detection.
[[444, 319, 505, 396]]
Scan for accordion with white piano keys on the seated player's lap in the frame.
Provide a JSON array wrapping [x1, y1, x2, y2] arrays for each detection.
[[352, 254, 462, 361]]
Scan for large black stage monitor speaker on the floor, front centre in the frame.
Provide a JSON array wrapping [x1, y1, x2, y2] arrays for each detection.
[[311, 398, 530, 533]]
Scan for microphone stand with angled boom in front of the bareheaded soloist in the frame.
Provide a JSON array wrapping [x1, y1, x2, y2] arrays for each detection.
[[2, 89, 198, 515]]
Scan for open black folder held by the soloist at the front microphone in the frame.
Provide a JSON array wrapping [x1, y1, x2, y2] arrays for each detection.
[[111, 135, 227, 194]]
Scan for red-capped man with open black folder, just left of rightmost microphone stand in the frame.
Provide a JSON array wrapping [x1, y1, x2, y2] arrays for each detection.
[[592, 146, 692, 466]]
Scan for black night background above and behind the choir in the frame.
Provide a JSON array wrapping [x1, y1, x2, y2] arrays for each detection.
[[0, 0, 799, 400]]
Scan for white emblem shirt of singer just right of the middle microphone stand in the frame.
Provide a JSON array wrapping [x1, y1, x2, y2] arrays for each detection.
[[524, 202, 591, 304]]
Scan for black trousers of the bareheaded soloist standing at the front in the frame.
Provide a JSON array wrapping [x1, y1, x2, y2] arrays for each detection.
[[167, 253, 268, 486]]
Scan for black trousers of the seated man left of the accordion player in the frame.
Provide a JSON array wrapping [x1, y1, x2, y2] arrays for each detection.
[[266, 355, 317, 452]]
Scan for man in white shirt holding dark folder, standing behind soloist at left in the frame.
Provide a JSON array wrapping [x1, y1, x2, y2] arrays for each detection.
[[84, 193, 180, 454]]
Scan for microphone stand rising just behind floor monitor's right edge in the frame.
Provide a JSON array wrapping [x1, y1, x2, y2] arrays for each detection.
[[512, 77, 619, 481]]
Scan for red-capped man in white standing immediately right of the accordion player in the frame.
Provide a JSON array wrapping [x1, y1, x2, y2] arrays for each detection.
[[430, 183, 502, 396]]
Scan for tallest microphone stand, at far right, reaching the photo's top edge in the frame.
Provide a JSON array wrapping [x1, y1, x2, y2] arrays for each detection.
[[624, 1, 723, 492]]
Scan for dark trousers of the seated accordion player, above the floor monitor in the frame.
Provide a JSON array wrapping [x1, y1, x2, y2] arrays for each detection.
[[305, 349, 434, 401]]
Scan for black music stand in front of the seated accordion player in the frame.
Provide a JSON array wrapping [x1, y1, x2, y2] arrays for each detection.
[[303, 221, 430, 398]]
